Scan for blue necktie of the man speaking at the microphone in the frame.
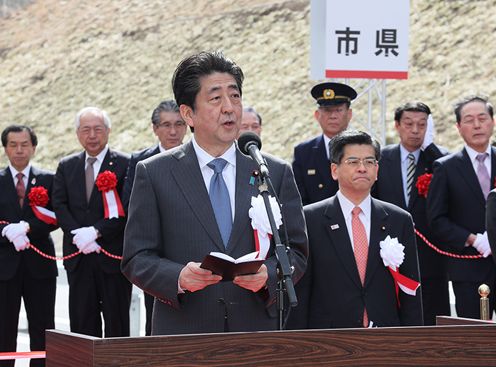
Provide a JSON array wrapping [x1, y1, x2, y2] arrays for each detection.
[[207, 158, 232, 247]]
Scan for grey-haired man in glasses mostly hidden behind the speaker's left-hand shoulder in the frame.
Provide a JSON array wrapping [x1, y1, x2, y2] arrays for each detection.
[[122, 100, 186, 335]]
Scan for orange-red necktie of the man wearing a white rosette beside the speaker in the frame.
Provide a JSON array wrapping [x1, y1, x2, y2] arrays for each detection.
[[351, 206, 369, 327]]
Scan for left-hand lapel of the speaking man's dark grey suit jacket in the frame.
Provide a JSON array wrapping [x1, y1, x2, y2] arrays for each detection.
[[172, 141, 225, 252]]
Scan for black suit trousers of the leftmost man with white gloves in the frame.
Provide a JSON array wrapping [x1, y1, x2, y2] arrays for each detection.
[[0, 260, 57, 367]]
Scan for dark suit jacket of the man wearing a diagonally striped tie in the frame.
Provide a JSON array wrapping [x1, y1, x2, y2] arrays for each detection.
[[372, 144, 448, 278]]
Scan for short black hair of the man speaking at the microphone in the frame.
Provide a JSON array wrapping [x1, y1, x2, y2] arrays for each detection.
[[172, 51, 244, 110]]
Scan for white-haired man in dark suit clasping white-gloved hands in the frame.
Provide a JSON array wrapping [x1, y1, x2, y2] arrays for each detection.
[[53, 107, 131, 337]]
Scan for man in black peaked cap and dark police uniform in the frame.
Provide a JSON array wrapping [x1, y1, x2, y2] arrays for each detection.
[[293, 83, 357, 205]]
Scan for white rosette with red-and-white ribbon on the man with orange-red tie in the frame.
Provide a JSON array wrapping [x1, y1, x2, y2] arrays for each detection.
[[379, 235, 420, 305]]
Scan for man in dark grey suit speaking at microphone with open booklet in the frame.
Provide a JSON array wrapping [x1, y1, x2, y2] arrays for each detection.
[[121, 52, 308, 335]]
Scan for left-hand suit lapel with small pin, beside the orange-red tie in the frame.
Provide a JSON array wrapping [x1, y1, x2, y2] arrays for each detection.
[[324, 196, 362, 288]]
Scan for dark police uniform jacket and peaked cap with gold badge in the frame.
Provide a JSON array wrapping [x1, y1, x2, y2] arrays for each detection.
[[293, 82, 357, 205]]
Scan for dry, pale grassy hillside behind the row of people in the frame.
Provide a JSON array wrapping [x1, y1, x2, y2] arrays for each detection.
[[0, 0, 496, 170]]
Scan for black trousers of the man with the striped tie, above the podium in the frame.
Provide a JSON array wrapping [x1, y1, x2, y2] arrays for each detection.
[[421, 276, 450, 325]]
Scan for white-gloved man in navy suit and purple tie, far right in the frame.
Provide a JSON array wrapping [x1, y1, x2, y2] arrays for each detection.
[[427, 96, 496, 318]]
